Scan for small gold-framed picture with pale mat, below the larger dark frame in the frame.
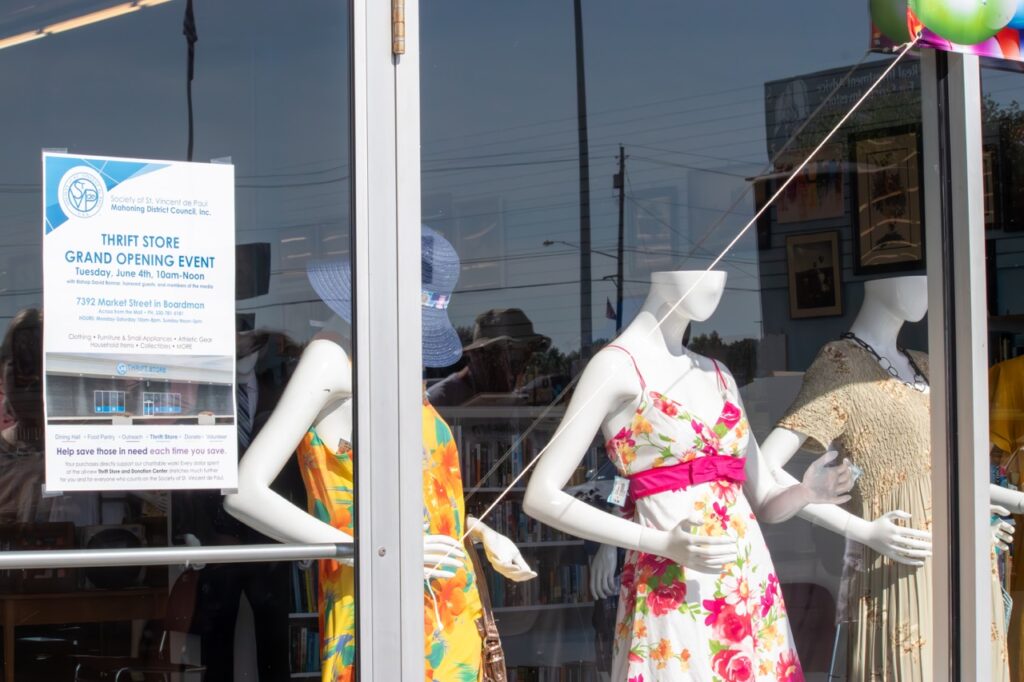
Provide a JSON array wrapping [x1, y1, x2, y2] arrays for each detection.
[[785, 230, 843, 319]]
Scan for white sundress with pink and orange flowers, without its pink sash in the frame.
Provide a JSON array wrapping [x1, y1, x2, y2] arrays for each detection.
[[606, 346, 804, 682]]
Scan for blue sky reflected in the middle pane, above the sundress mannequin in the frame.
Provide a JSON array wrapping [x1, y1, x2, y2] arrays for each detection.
[[421, 0, 868, 348]]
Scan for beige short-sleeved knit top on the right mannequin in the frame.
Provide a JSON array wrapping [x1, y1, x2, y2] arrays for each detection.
[[778, 339, 932, 512]]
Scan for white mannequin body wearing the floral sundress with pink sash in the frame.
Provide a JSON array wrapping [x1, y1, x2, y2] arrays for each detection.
[[523, 270, 852, 569]]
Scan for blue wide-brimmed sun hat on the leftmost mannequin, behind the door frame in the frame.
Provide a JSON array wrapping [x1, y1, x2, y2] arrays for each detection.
[[306, 225, 462, 368]]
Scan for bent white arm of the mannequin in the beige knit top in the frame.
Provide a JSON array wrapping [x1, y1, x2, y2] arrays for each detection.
[[762, 428, 932, 566]]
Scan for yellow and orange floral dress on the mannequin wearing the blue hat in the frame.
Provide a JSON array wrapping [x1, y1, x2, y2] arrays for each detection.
[[298, 400, 482, 682]]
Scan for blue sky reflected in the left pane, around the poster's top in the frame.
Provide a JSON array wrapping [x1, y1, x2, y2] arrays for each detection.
[[0, 0, 348, 338]]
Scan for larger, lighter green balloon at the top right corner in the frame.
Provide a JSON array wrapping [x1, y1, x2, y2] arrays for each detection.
[[909, 0, 1018, 45]]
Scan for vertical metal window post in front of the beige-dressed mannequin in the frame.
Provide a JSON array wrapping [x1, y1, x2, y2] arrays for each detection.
[[922, 50, 992, 680]]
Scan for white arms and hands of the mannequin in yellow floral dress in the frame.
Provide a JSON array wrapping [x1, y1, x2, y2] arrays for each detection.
[[224, 338, 536, 581]]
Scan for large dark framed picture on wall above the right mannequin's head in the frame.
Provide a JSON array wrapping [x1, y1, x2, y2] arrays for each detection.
[[850, 125, 925, 274]]
